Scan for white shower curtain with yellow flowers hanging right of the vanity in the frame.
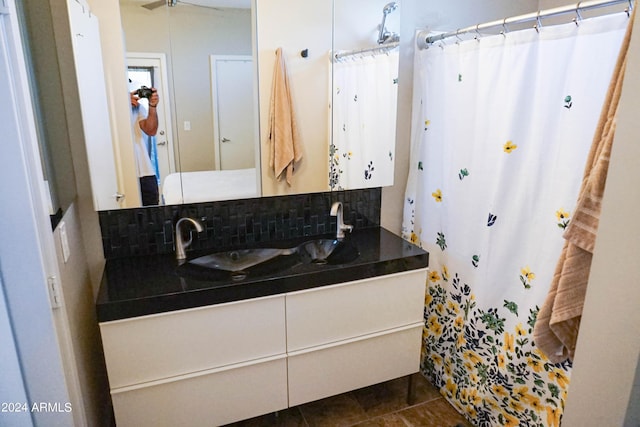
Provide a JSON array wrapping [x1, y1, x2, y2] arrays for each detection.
[[403, 14, 628, 426]]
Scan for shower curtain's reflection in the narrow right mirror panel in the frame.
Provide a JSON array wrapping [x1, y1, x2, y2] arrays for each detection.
[[329, 49, 398, 190]]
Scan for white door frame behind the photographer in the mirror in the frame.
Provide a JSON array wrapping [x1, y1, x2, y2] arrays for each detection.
[[127, 52, 176, 194]]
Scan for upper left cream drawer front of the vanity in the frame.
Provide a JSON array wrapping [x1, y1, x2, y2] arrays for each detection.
[[100, 296, 286, 389]]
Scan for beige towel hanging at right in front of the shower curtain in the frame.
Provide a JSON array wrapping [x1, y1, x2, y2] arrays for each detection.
[[533, 8, 635, 363]]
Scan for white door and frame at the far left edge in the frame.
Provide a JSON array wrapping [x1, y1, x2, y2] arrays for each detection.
[[0, 0, 76, 426]]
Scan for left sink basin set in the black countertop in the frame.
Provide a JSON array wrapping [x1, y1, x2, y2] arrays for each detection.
[[189, 248, 296, 272]]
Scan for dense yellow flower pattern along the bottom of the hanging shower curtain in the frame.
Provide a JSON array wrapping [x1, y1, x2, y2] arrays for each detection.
[[422, 266, 570, 427]]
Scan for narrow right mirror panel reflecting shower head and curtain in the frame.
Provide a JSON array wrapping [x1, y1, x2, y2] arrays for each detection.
[[329, 0, 400, 190]]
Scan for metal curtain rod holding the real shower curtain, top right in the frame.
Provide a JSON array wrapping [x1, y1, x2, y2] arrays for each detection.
[[417, 0, 633, 49]]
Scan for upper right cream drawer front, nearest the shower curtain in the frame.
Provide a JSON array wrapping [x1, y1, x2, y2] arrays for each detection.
[[286, 269, 427, 351]]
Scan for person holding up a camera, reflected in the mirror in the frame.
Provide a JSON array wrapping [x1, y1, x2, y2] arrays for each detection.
[[131, 83, 160, 206]]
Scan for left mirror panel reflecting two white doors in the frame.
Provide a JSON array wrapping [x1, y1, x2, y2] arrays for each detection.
[[119, 0, 260, 204]]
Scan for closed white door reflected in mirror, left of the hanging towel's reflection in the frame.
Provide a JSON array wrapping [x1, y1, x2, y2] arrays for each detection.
[[211, 55, 256, 170]]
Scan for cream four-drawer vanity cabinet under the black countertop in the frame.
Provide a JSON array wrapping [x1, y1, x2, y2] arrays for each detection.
[[100, 269, 427, 427]]
